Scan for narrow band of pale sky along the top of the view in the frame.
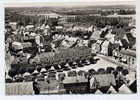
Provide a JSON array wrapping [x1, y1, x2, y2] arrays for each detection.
[[5, 0, 136, 8]]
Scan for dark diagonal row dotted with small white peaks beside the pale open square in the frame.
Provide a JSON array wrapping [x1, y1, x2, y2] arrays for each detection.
[[5, 57, 98, 81]]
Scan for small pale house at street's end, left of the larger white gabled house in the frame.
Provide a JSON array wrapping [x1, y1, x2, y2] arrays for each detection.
[[92, 40, 103, 53]]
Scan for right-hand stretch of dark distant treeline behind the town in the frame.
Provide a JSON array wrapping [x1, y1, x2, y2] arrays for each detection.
[[67, 16, 131, 27]]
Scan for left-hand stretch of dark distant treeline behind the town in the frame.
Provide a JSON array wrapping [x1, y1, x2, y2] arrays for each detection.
[[5, 13, 58, 26]]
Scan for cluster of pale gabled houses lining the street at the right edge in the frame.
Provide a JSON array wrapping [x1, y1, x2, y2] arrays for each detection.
[[90, 23, 136, 67]]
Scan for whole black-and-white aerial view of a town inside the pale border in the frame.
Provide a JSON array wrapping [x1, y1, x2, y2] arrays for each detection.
[[4, 0, 137, 96]]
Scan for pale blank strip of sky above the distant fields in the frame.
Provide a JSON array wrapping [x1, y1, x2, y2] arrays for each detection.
[[5, 0, 136, 7]]
